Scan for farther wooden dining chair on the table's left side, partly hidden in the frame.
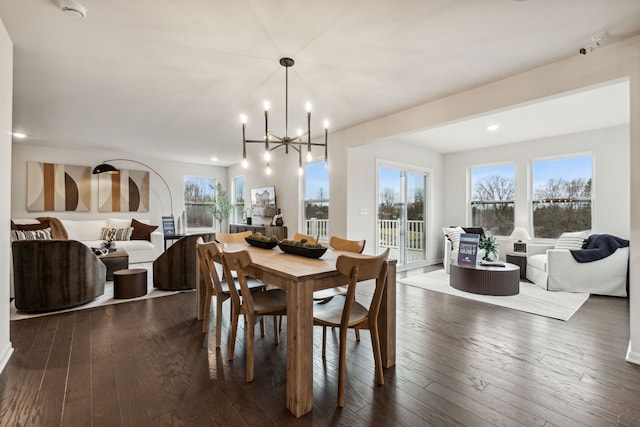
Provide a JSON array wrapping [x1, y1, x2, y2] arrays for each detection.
[[196, 242, 266, 347]]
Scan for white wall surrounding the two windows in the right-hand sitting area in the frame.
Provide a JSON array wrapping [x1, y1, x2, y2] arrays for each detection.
[[443, 126, 630, 239]]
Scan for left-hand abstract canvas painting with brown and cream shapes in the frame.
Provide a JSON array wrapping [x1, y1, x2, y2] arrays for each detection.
[[27, 162, 91, 212]]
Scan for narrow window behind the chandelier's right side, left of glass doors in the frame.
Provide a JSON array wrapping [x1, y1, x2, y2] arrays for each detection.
[[302, 161, 329, 240]]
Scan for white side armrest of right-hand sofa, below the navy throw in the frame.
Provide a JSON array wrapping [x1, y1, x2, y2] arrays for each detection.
[[547, 248, 629, 297]]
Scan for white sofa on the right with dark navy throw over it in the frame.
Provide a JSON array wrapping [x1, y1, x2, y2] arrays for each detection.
[[527, 244, 629, 297]]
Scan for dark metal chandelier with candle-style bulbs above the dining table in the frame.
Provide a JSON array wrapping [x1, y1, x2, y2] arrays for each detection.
[[240, 58, 329, 175]]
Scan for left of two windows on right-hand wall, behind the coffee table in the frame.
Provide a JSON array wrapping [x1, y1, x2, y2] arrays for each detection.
[[468, 165, 515, 236]]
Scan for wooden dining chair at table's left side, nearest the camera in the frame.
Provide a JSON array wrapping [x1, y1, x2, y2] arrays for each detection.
[[222, 247, 287, 382]]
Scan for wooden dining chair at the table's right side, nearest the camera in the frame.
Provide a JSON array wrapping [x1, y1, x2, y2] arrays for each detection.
[[313, 248, 389, 407]]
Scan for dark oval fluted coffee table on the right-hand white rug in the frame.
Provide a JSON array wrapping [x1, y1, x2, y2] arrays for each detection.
[[449, 261, 520, 296]]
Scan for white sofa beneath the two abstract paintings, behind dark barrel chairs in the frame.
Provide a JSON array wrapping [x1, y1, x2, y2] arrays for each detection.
[[13, 218, 164, 264]]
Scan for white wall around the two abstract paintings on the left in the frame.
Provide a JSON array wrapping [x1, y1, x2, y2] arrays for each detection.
[[11, 141, 227, 231]]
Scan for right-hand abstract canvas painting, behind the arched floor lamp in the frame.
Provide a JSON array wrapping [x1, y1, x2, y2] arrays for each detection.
[[98, 169, 149, 212]]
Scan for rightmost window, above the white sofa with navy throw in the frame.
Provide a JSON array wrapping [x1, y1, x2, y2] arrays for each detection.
[[531, 156, 593, 239]]
